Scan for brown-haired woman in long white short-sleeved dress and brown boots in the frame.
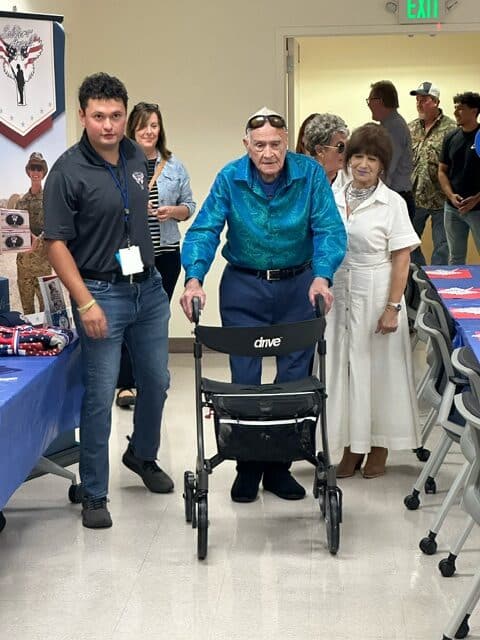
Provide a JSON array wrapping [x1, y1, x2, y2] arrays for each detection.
[[326, 124, 420, 478]]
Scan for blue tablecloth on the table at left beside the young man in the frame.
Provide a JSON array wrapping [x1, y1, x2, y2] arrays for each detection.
[[0, 340, 83, 510]]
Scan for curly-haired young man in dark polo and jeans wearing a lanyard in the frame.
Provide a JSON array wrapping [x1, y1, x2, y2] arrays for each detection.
[[44, 73, 173, 528]]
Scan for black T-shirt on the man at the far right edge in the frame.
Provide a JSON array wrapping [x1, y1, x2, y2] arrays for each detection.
[[440, 126, 480, 198]]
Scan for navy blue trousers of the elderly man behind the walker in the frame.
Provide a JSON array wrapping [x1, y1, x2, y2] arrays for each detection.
[[220, 266, 315, 384]]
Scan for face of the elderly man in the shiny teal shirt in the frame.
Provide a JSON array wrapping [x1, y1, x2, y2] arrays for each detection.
[[243, 122, 287, 182]]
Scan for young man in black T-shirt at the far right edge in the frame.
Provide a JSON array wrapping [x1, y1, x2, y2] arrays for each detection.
[[438, 91, 480, 264]]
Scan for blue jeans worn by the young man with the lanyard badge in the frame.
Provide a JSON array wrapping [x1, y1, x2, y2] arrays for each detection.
[[72, 272, 170, 498]]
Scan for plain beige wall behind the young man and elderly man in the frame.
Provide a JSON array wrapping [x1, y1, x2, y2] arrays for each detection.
[[0, 0, 480, 337]]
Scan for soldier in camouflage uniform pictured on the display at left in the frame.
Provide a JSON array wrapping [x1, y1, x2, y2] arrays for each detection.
[[15, 152, 52, 313]]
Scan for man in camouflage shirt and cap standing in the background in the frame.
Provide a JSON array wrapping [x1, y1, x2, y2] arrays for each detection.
[[408, 82, 456, 265]]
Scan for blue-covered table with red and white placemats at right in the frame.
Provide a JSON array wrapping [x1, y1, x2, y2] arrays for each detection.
[[423, 265, 480, 362]]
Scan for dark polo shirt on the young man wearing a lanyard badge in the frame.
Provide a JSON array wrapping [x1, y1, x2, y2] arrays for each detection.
[[43, 132, 154, 272]]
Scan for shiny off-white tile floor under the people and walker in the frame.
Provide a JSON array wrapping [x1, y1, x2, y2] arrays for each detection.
[[0, 354, 480, 640]]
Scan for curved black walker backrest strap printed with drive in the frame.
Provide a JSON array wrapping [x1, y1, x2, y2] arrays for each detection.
[[194, 316, 326, 357]]
